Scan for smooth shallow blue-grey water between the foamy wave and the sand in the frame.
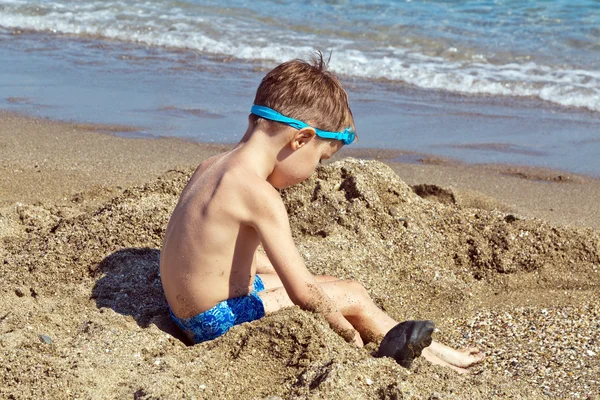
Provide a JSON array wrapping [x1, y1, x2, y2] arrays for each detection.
[[0, 35, 600, 178]]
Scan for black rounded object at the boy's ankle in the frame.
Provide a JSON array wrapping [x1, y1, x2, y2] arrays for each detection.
[[375, 321, 435, 368]]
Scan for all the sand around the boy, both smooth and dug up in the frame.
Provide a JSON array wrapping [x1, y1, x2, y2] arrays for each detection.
[[0, 114, 600, 399]]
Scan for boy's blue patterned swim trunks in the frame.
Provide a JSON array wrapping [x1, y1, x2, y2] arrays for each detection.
[[169, 275, 265, 344]]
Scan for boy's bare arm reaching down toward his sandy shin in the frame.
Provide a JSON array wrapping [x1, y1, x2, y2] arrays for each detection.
[[252, 185, 360, 343]]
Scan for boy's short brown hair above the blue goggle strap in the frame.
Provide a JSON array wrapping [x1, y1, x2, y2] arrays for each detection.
[[254, 52, 354, 141]]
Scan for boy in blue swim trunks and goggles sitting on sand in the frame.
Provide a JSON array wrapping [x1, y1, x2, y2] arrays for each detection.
[[160, 54, 482, 372]]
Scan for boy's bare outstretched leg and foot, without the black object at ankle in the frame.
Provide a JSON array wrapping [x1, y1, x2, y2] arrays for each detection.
[[258, 274, 483, 373]]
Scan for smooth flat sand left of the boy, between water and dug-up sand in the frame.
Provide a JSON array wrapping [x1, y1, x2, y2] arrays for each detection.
[[0, 112, 224, 206]]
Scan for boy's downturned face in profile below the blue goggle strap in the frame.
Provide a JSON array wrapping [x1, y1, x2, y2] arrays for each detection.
[[267, 137, 344, 189]]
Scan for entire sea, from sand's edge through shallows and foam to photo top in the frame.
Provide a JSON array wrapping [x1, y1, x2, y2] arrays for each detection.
[[0, 0, 600, 177]]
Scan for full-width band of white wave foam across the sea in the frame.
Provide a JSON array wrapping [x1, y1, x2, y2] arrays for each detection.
[[0, 0, 600, 111]]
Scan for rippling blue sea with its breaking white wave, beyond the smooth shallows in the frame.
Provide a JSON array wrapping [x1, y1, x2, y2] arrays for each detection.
[[0, 0, 600, 111]]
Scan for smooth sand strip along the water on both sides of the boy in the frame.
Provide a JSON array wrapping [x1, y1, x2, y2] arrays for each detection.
[[0, 110, 600, 229]]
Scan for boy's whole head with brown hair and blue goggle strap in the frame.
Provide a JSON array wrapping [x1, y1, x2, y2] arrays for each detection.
[[251, 53, 355, 188]]
